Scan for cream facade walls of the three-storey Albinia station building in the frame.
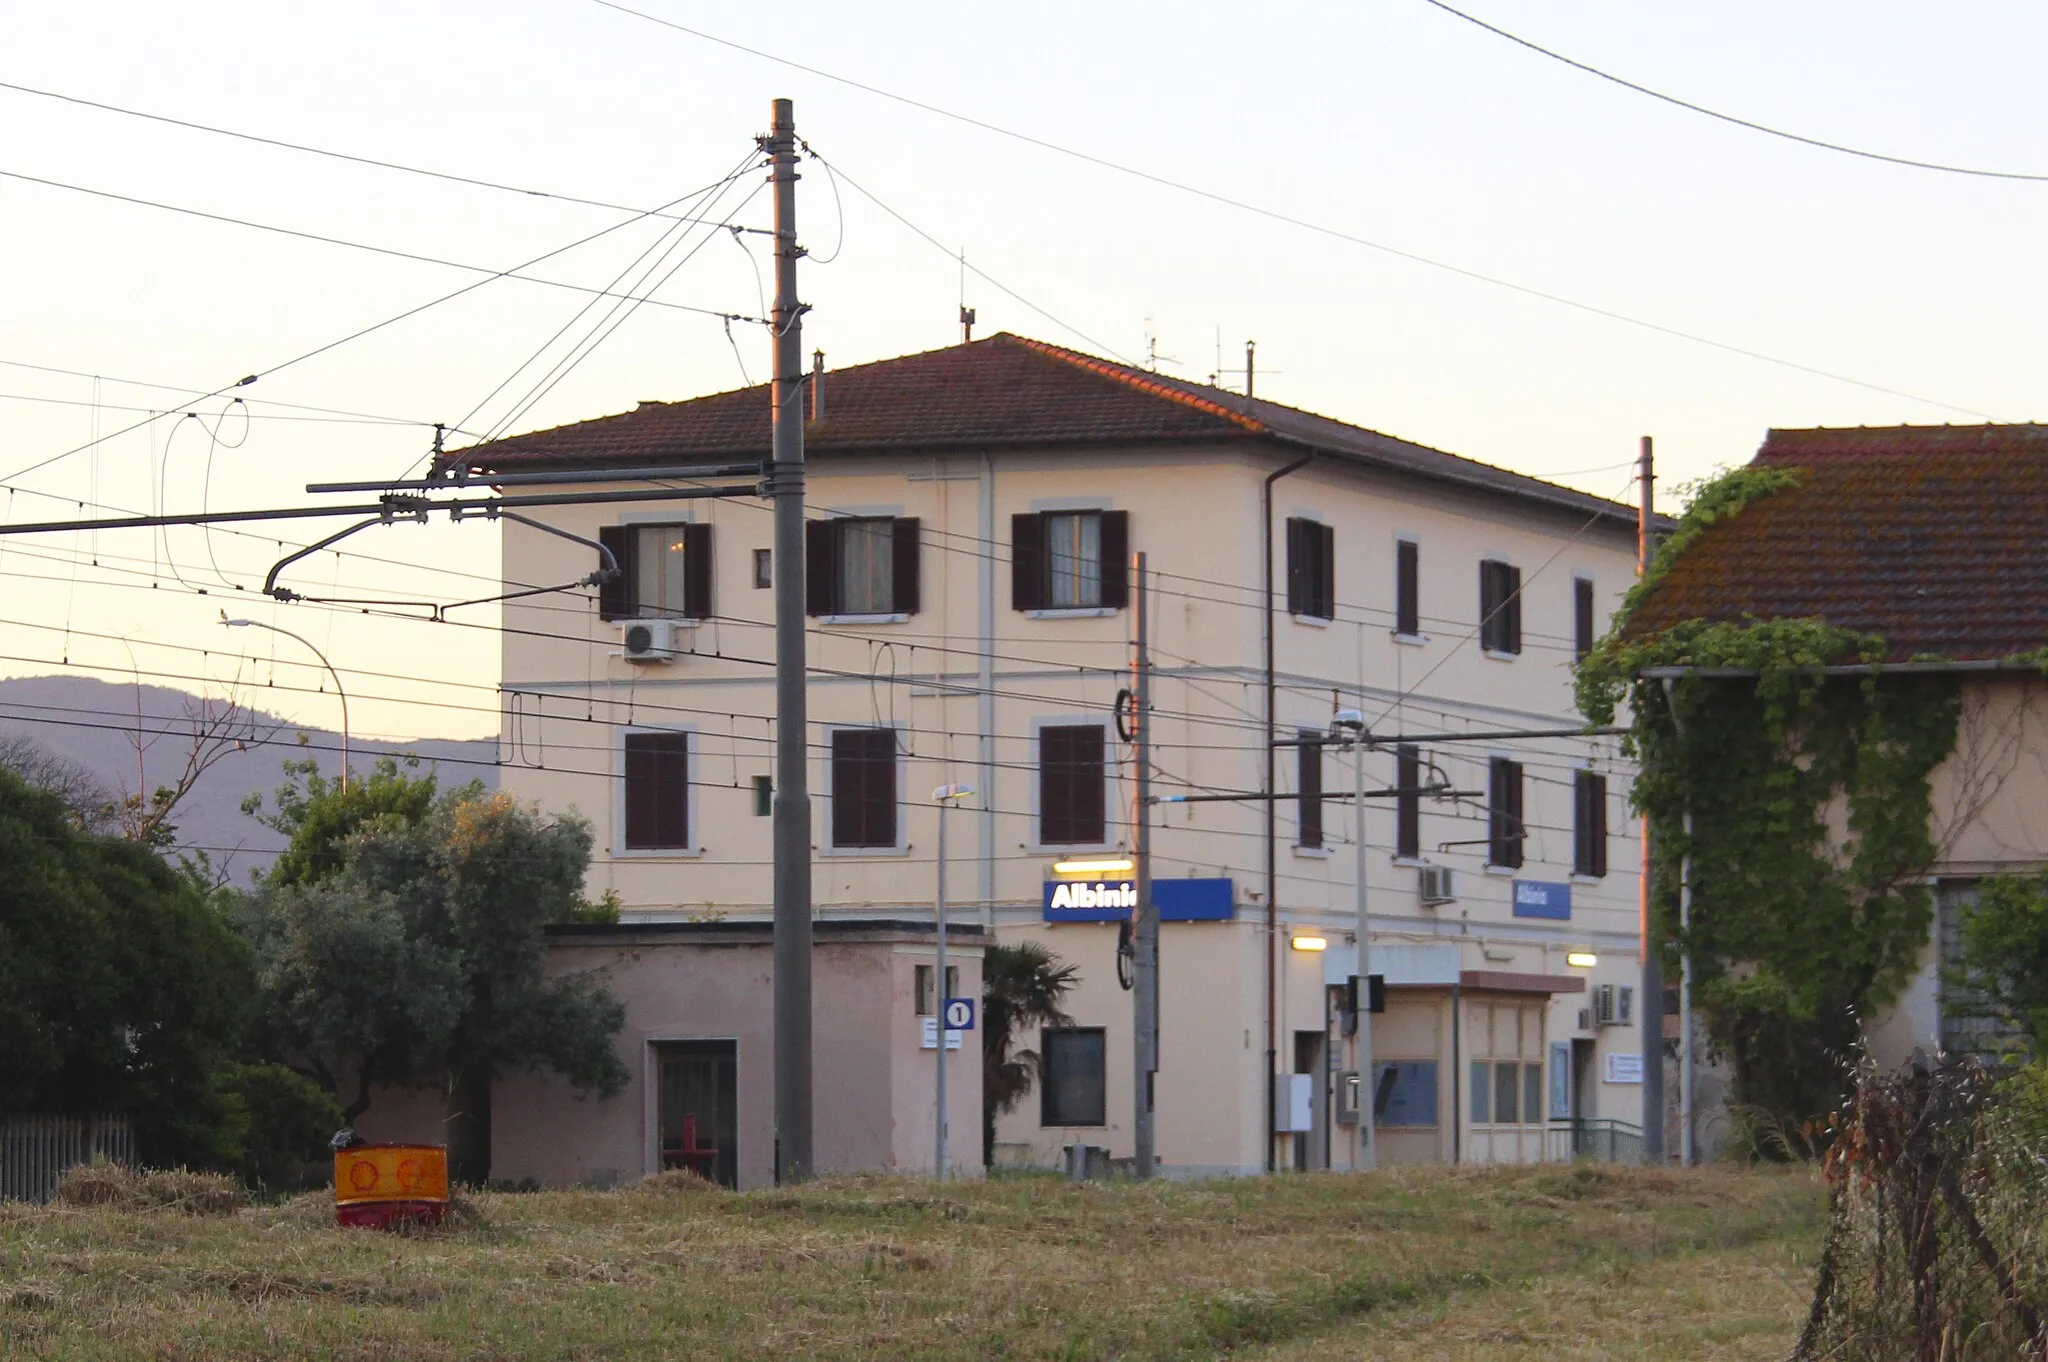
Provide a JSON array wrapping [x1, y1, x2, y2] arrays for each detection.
[[502, 438, 1649, 1174]]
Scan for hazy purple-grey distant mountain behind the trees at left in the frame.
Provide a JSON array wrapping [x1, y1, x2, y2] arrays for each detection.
[[0, 676, 498, 883]]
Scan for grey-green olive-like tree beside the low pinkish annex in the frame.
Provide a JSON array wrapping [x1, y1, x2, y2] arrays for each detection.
[[244, 766, 627, 1182]]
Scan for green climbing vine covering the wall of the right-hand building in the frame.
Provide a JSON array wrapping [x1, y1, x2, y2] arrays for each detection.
[[1577, 469, 1960, 1122]]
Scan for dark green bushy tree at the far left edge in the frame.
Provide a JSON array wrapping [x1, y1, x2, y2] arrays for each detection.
[[0, 772, 252, 1167]]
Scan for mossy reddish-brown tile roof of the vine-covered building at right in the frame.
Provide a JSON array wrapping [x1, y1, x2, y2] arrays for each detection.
[[1630, 426, 2048, 662]]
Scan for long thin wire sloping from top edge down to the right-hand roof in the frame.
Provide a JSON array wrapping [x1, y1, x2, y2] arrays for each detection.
[[590, 0, 1999, 420]]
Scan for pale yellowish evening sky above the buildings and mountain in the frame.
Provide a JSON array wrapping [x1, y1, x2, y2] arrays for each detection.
[[0, 0, 2048, 737]]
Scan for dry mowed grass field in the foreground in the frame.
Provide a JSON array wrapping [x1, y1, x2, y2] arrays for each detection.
[[0, 1165, 1823, 1360]]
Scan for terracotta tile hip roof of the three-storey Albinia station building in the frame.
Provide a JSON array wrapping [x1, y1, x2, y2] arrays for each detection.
[[459, 332, 1634, 522]]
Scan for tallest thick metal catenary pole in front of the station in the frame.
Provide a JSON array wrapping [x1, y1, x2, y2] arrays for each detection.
[[764, 98, 811, 1182]]
